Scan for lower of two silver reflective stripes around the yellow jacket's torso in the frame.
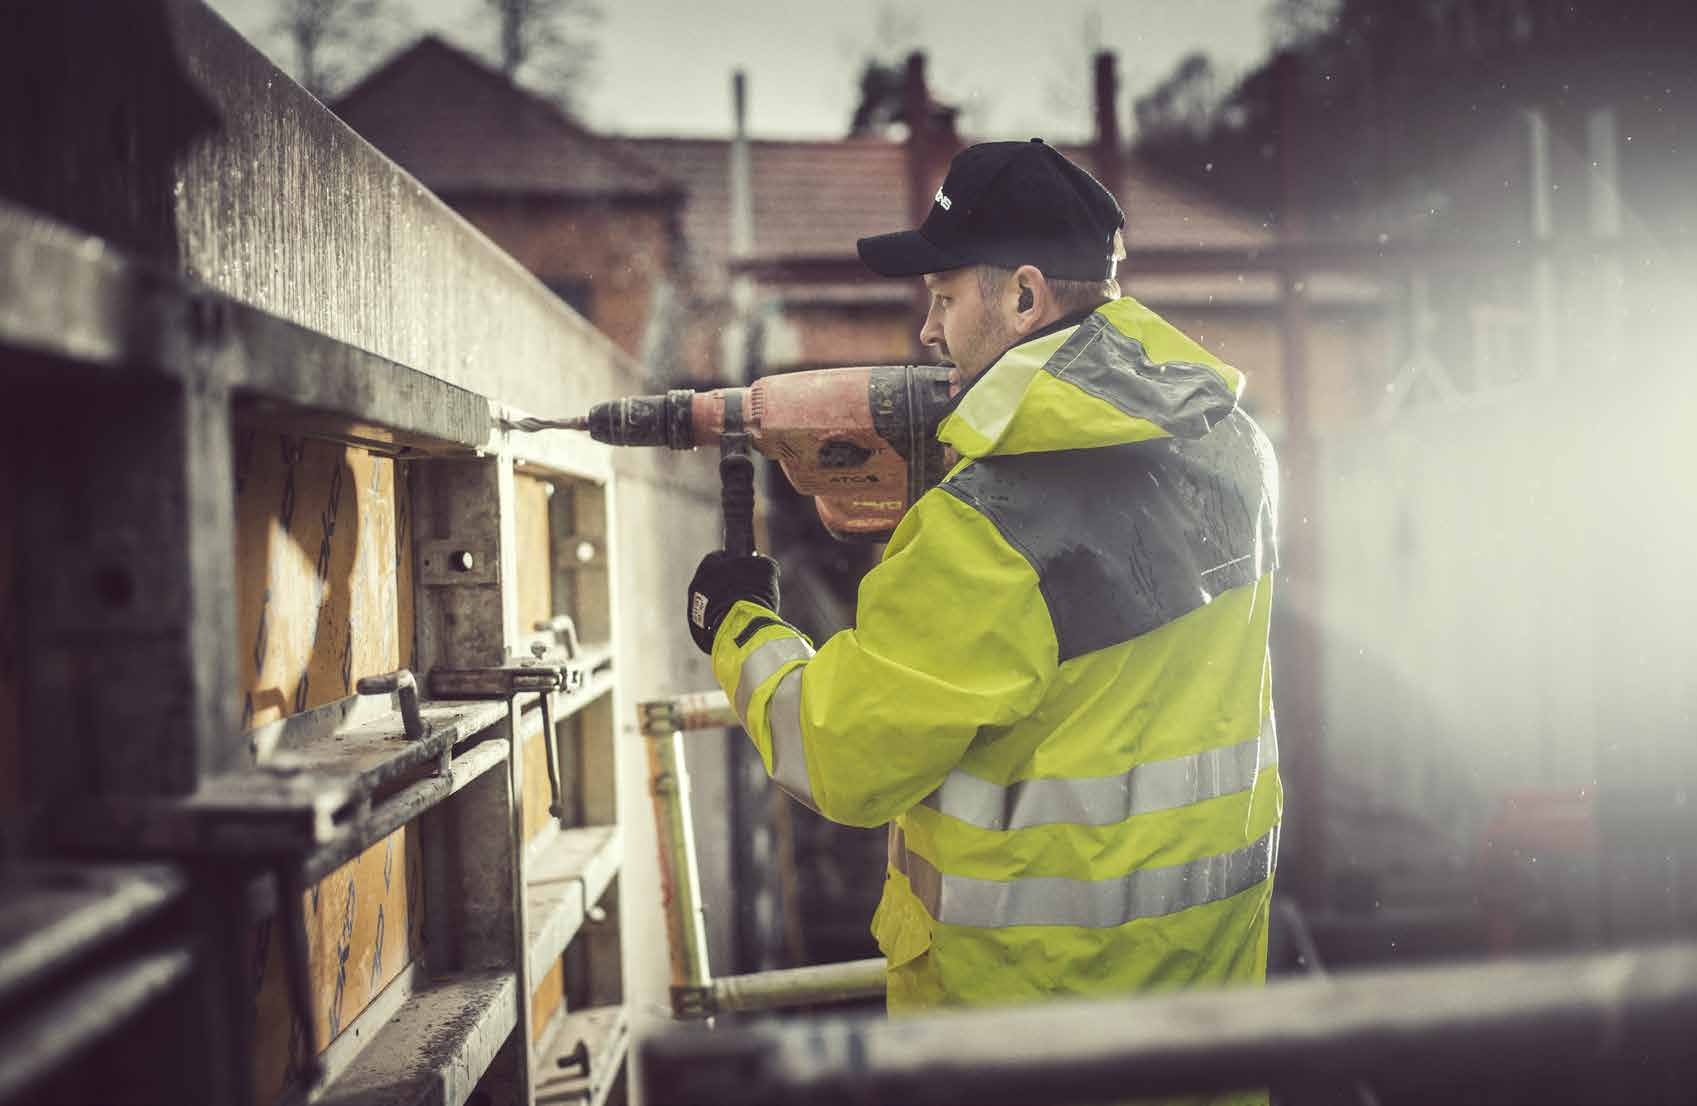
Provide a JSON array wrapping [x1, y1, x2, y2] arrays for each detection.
[[891, 826, 1278, 930]]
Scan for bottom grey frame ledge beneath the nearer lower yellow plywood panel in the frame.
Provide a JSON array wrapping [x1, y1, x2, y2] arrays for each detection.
[[314, 972, 518, 1106]]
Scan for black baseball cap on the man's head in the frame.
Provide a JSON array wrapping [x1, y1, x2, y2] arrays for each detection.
[[855, 139, 1125, 280]]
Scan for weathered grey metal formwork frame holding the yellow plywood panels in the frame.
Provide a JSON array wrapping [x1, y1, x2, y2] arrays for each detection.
[[0, 205, 628, 1103]]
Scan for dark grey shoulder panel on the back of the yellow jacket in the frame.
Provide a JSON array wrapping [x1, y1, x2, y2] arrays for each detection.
[[942, 411, 1278, 662]]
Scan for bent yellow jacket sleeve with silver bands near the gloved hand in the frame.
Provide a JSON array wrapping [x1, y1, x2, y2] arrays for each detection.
[[713, 489, 1057, 826]]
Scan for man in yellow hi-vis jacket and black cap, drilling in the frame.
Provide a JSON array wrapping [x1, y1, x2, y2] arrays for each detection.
[[691, 139, 1281, 1011]]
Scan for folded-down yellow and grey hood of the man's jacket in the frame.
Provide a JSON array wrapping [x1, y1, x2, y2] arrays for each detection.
[[937, 297, 1244, 458]]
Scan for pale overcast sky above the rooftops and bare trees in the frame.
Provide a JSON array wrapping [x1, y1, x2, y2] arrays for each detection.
[[212, 0, 1268, 139]]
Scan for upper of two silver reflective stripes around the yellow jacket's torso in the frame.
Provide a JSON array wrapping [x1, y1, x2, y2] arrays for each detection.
[[923, 716, 1278, 830]]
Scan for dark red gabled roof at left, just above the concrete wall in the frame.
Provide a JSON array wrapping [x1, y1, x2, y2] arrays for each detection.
[[334, 36, 677, 198]]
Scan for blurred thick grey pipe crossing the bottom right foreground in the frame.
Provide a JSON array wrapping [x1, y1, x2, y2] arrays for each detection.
[[641, 943, 1697, 1106]]
